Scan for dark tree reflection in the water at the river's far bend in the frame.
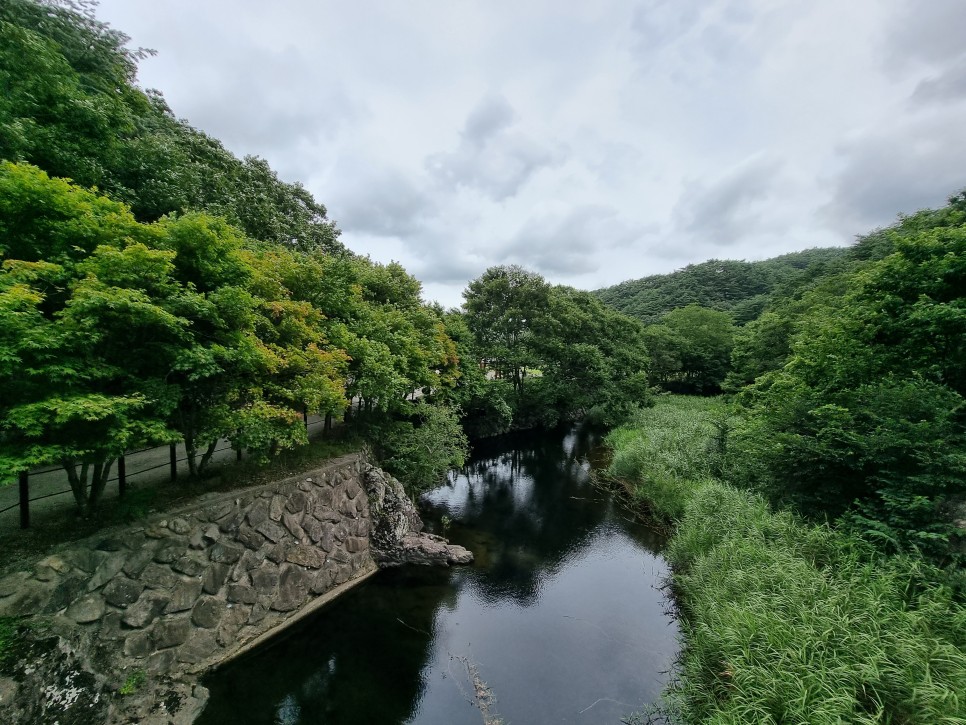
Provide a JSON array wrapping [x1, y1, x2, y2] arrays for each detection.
[[424, 427, 611, 605]]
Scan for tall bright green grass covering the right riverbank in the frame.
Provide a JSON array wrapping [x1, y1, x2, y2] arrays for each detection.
[[608, 398, 966, 723]]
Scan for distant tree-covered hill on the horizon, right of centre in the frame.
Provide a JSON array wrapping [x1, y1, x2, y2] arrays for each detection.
[[595, 247, 851, 325]]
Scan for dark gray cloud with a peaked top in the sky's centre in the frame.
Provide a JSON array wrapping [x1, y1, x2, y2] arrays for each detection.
[[426, 96, 563, 201]]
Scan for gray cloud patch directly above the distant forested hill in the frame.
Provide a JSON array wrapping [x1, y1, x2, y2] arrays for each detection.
[[673, 154, 782, 246]]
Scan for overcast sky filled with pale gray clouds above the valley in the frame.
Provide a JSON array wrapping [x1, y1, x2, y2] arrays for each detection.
[[92, 0, 966, 305]]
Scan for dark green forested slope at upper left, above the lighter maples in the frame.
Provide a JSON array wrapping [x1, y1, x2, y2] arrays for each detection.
[[0, 0, 344, 253]]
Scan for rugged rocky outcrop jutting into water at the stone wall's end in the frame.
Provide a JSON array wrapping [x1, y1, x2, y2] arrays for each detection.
[[363, 466, 473, 567]]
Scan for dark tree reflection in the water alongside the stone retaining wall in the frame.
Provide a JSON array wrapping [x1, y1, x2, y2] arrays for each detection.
[[197, 569, 457, 725]]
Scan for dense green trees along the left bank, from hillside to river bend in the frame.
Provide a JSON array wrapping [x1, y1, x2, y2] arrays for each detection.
[[0, 0, 649, 513]]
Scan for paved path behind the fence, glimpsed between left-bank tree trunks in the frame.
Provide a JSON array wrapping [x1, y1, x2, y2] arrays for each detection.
[[0, 415, 323, 531]]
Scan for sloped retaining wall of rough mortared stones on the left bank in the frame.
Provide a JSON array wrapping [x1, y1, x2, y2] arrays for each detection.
[[0, 455, 376, 723]]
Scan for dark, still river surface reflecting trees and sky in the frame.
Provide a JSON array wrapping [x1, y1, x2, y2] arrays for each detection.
[[198, 428, 677, 725]]
